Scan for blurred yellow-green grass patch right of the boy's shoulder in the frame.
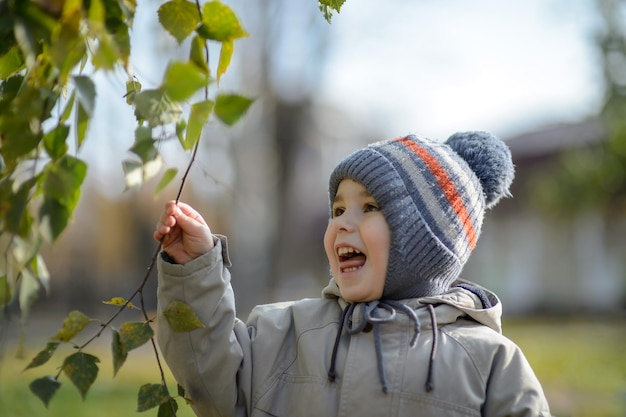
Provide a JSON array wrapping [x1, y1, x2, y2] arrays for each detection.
[[504, 318, 626, 417]]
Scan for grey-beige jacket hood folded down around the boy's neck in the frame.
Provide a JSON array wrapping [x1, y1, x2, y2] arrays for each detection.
[[322, 278, 502, 333]]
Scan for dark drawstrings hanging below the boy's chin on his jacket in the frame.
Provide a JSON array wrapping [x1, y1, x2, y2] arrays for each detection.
[[328, 300, 437, 393]]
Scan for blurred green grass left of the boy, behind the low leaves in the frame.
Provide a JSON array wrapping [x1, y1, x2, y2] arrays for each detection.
[[0, 320, 195, 417]]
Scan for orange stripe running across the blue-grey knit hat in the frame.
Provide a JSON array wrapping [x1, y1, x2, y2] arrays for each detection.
[[397, 137, 477, 250]]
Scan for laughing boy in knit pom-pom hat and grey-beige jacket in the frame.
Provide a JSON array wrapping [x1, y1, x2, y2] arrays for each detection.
[[154, 132, 550, 417]]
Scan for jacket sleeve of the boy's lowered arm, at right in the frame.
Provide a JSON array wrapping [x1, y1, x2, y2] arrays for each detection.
[[482, 340, 551, 417]]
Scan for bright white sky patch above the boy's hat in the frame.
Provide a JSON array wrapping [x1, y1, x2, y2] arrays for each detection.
[[320, 0, 602, 137]]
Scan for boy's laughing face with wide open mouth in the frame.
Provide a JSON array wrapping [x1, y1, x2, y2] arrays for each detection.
[[324, 179, 391, 302]]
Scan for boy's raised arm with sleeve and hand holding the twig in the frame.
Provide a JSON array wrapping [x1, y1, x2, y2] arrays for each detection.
[[154, 202, 250, 417]]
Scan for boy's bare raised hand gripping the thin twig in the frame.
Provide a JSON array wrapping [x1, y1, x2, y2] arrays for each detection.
[[153, 201, 214, 264]]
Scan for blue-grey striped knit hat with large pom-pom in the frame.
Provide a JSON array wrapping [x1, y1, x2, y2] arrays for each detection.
[[329, 132, 514, 300]]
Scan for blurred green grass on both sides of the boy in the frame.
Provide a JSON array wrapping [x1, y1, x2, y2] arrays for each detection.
[[0, 318, 626, 417]]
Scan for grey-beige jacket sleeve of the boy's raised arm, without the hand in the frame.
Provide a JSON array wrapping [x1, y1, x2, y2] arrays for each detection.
[[157, 237, 251, 417]]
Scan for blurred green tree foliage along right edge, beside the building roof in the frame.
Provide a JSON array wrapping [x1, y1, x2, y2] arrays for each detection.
[[532, 0, 626, 217]]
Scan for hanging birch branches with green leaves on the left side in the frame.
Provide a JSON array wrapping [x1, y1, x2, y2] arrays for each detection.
[[1, 0, 252, 415]]
